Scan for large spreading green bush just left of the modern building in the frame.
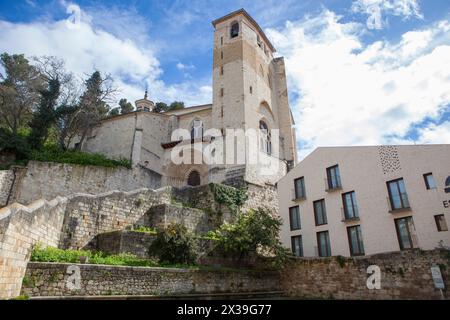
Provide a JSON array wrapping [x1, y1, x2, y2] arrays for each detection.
[[208, 208, 287, 264]]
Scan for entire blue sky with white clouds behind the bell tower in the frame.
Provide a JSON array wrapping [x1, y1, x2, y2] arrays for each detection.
[[0, 0, 450, 157]]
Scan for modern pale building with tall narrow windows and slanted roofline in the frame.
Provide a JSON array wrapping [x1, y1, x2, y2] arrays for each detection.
[[278, 145, 450, 257]]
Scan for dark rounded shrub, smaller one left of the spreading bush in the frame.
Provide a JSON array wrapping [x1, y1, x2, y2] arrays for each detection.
[[150, 224, 198, 264]]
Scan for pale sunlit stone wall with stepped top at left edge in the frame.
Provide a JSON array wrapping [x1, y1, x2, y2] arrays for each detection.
[[0, 197, 67, 299]]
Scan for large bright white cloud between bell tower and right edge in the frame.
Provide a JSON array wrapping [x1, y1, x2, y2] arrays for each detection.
[[268, 10, 450, 157]]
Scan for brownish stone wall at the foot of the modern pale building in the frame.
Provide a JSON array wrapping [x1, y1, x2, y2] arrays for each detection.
[[281, 250, 450, 299]]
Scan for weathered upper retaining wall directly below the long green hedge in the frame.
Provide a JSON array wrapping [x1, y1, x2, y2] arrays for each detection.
[[10, 161, 161, 204]]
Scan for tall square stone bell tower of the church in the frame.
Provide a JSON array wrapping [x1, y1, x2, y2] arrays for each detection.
[[212, 9, 297, 183]]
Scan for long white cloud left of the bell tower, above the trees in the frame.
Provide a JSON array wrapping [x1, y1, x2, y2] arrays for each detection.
[[0, 1, 211, 105]]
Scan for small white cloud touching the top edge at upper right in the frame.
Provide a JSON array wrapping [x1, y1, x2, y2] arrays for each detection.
[[352, 0, 423, 29]]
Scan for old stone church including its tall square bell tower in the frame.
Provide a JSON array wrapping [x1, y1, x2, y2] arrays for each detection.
[[75, 9, 297, 187]]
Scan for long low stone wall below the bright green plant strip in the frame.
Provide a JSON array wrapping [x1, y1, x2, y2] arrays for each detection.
[[22, 262, 279, 297]]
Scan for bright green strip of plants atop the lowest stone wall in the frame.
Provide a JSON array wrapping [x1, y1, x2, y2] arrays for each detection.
[[31, 246, 157, 267]]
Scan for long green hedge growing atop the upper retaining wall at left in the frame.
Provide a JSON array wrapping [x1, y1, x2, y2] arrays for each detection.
[[30, 146, 131, 168]]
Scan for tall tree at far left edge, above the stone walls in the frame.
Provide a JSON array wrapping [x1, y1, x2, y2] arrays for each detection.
[[0, 53, 44, 136]]
